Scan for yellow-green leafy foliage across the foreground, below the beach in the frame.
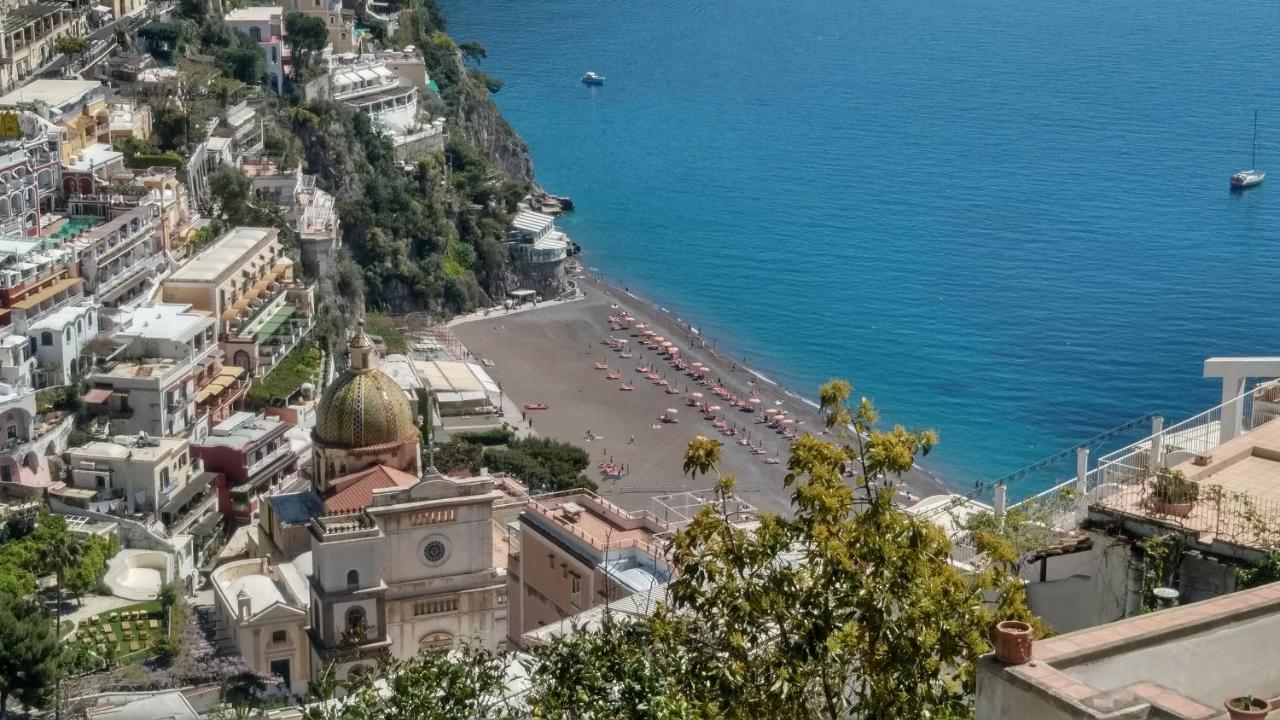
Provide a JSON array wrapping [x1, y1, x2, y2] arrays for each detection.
[[302, 384, 1018, 720]]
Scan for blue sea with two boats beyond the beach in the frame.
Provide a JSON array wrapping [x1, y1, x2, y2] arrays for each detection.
[[443, 0, 1280, 487]]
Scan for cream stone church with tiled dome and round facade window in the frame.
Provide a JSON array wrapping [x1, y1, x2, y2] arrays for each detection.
[[232, 327, 507, 679]]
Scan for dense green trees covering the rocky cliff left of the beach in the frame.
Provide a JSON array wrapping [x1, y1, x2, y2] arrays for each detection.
[[292, 102, 525, 313]]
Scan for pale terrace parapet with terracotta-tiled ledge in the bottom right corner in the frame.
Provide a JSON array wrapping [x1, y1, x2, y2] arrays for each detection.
[[975, 583, 1280, 720]]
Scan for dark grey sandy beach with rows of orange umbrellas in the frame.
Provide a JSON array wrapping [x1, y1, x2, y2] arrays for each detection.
[[452, 271, 945, 512]]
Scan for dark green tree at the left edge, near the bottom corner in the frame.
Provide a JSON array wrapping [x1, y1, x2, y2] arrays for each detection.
[[0, 593, 60, 716]]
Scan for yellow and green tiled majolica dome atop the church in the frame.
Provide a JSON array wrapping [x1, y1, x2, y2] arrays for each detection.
[[315, 328, 419, 450]]
